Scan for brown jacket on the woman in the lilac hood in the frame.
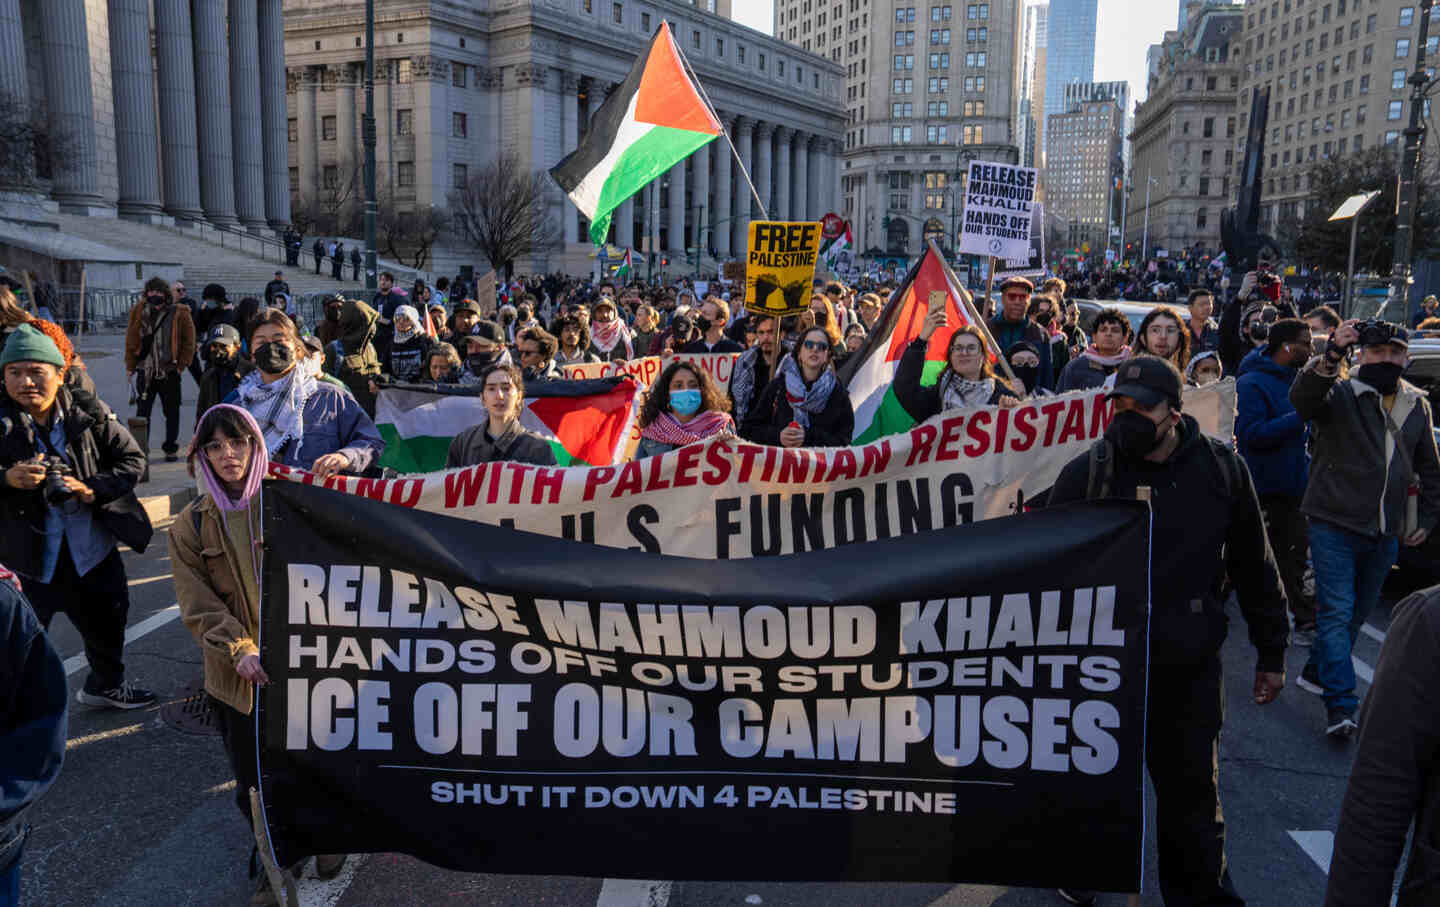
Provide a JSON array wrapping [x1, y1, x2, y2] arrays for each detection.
[[170, 495, 261, 716]]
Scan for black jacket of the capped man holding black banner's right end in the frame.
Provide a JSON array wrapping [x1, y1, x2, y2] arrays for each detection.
[[1047, 416, 1289, 671]]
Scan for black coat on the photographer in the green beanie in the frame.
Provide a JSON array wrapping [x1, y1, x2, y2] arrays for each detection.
[[0, 387, 154, 576]]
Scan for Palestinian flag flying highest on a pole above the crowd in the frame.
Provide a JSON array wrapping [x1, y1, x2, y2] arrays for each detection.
[[550, 22, 721, 245]]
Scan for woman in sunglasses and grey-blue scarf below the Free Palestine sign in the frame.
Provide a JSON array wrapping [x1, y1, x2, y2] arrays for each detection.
[[740, 327, 855, 448]]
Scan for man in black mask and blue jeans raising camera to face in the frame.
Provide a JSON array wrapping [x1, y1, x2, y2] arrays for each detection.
[[1290, 320, 1440, 739]]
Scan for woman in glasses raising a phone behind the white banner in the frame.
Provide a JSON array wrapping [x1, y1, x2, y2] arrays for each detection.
[[894, 311, 1020, 422]]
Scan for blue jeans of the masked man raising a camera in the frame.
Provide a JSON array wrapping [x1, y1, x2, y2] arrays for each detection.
[[1310, 520, 1400, 711]]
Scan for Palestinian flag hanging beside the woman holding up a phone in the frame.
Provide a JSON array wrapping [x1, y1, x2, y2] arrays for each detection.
[[840, 240, 996, 445]]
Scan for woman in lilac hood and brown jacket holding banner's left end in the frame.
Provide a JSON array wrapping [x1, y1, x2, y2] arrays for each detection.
[[170, 403, 346, 904]]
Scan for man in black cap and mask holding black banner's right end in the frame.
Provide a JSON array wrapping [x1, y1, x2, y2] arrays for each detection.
[[1050, 356, 1289, 904]]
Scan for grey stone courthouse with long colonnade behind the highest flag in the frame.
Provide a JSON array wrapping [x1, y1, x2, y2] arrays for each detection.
[[280, 0, 845, 274]]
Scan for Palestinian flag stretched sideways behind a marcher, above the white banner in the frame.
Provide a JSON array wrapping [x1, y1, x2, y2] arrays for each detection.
[[374, 377, 641, 472]]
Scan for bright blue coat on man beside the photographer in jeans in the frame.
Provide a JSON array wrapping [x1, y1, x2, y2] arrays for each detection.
[[1236, 350, 1310, 501]]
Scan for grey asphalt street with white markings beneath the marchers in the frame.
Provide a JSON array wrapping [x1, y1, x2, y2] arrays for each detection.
[[22, 331, 1413, 907]]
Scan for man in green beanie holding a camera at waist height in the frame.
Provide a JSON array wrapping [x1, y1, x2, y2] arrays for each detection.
[[0, 325, 156, 708]]
